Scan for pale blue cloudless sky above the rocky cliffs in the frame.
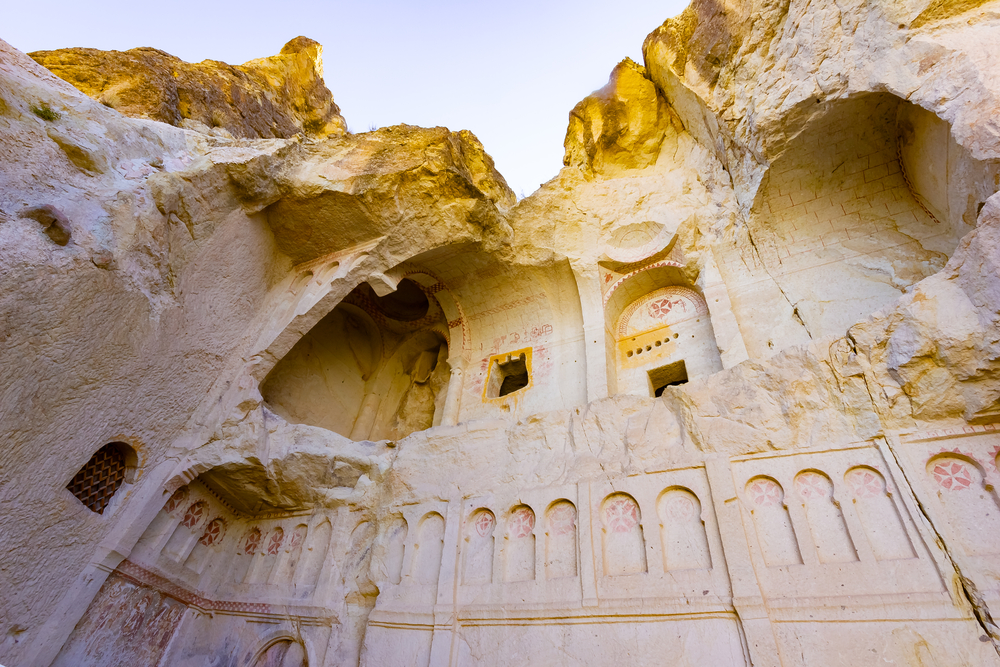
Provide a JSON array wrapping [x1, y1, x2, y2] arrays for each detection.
[[0, 0, 687, 195]]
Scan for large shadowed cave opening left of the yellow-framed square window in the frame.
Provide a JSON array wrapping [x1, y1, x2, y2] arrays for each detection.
[[261, 276, 450, 440]]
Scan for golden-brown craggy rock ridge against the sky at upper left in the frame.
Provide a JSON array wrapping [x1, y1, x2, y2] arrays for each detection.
[[31, 37, 347, 139]]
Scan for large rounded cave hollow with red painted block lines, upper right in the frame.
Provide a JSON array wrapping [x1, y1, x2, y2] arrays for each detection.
[[748, 93, 1000, 344]]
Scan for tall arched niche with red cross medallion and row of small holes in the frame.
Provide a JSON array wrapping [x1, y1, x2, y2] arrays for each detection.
[[605, 262, 722, 396]]
